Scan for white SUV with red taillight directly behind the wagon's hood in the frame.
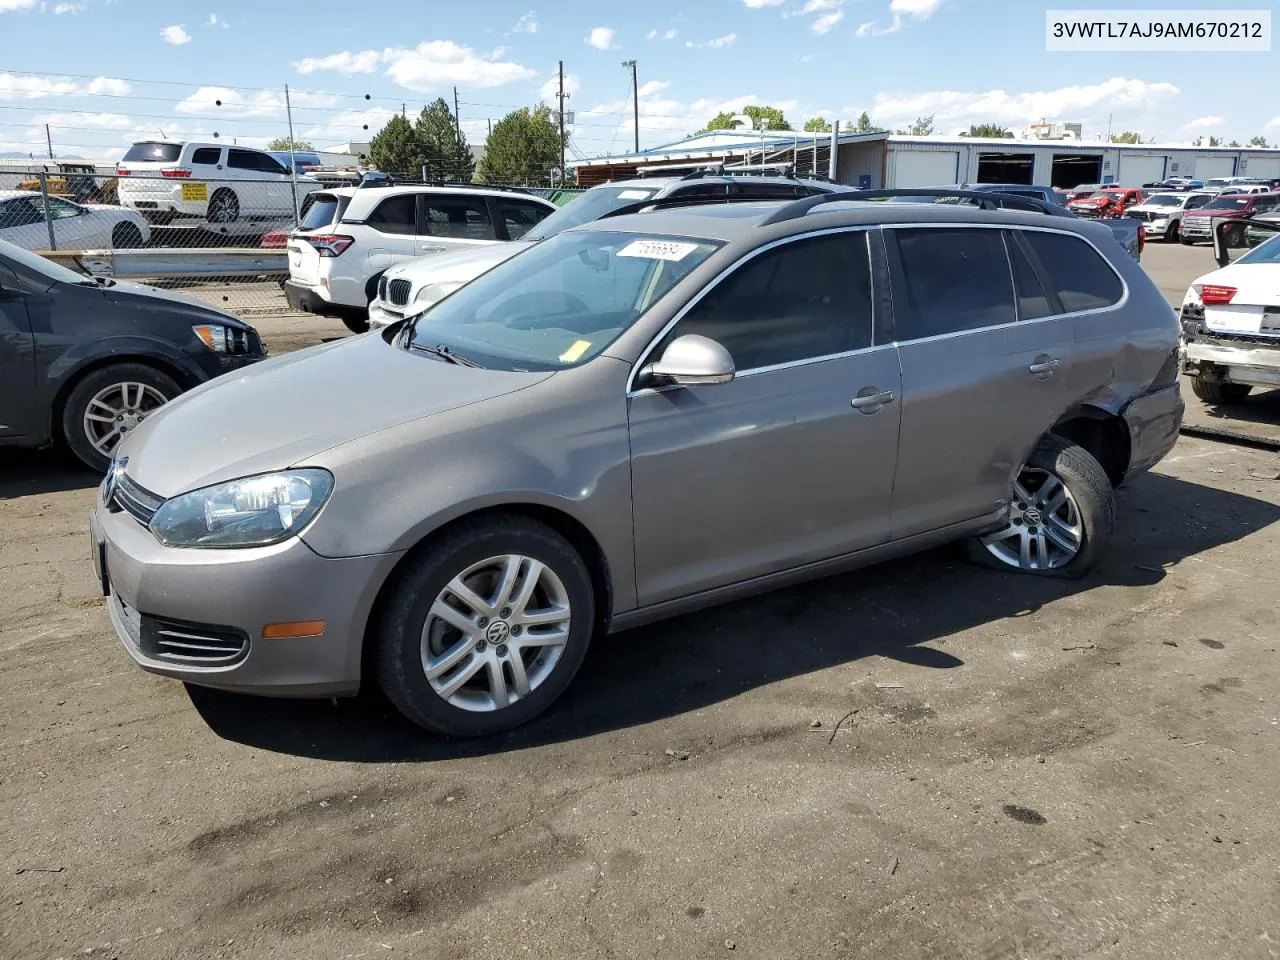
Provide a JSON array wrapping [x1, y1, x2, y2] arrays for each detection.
[[284, 186, 556, 333]]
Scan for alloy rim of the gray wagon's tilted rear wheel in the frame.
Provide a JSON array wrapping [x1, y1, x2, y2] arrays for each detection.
[[982, 467, 1084, 570]]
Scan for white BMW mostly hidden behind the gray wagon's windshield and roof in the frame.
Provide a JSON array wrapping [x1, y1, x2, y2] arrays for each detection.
[[369, 170, 847, 330]]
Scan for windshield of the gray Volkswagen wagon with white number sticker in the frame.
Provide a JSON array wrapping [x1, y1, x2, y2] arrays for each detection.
[[410, 229, 719, 371]]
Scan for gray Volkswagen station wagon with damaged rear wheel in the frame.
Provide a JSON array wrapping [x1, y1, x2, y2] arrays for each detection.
[[91, 196, 1183, 735]]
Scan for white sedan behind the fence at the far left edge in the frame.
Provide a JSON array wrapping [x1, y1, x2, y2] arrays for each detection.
[[0, 189, 151, 250]]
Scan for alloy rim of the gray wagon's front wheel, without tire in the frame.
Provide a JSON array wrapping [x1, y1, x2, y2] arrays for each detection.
[[421, 554, 572, 712]]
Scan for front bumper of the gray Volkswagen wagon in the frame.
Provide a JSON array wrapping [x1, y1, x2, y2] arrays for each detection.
[[90, 492, 402, 696]]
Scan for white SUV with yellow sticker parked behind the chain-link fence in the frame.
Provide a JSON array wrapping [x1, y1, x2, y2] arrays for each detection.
[[115, 140, 320, 224]]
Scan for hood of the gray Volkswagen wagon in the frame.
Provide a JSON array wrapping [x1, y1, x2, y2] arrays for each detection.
[[119, 334, 552, 497]]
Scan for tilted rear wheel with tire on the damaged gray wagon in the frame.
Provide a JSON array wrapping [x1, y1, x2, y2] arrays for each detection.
[[969, 434, 1115, 579]]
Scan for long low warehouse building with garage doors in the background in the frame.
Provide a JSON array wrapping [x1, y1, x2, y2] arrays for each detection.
[[568, 131, 1280, 189]]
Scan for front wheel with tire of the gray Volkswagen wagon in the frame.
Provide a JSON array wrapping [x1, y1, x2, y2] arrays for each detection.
[[376, 516, 595, 736]]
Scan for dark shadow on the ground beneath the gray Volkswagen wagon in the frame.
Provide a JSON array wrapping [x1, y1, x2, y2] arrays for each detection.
[[188, 475, 1280, 763]]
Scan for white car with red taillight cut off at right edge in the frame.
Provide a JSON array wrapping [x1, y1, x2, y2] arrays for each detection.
[[1181, 236, 1280, 403]]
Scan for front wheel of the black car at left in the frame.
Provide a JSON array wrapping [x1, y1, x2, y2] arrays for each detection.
[[61, 364, 182, 472]]
